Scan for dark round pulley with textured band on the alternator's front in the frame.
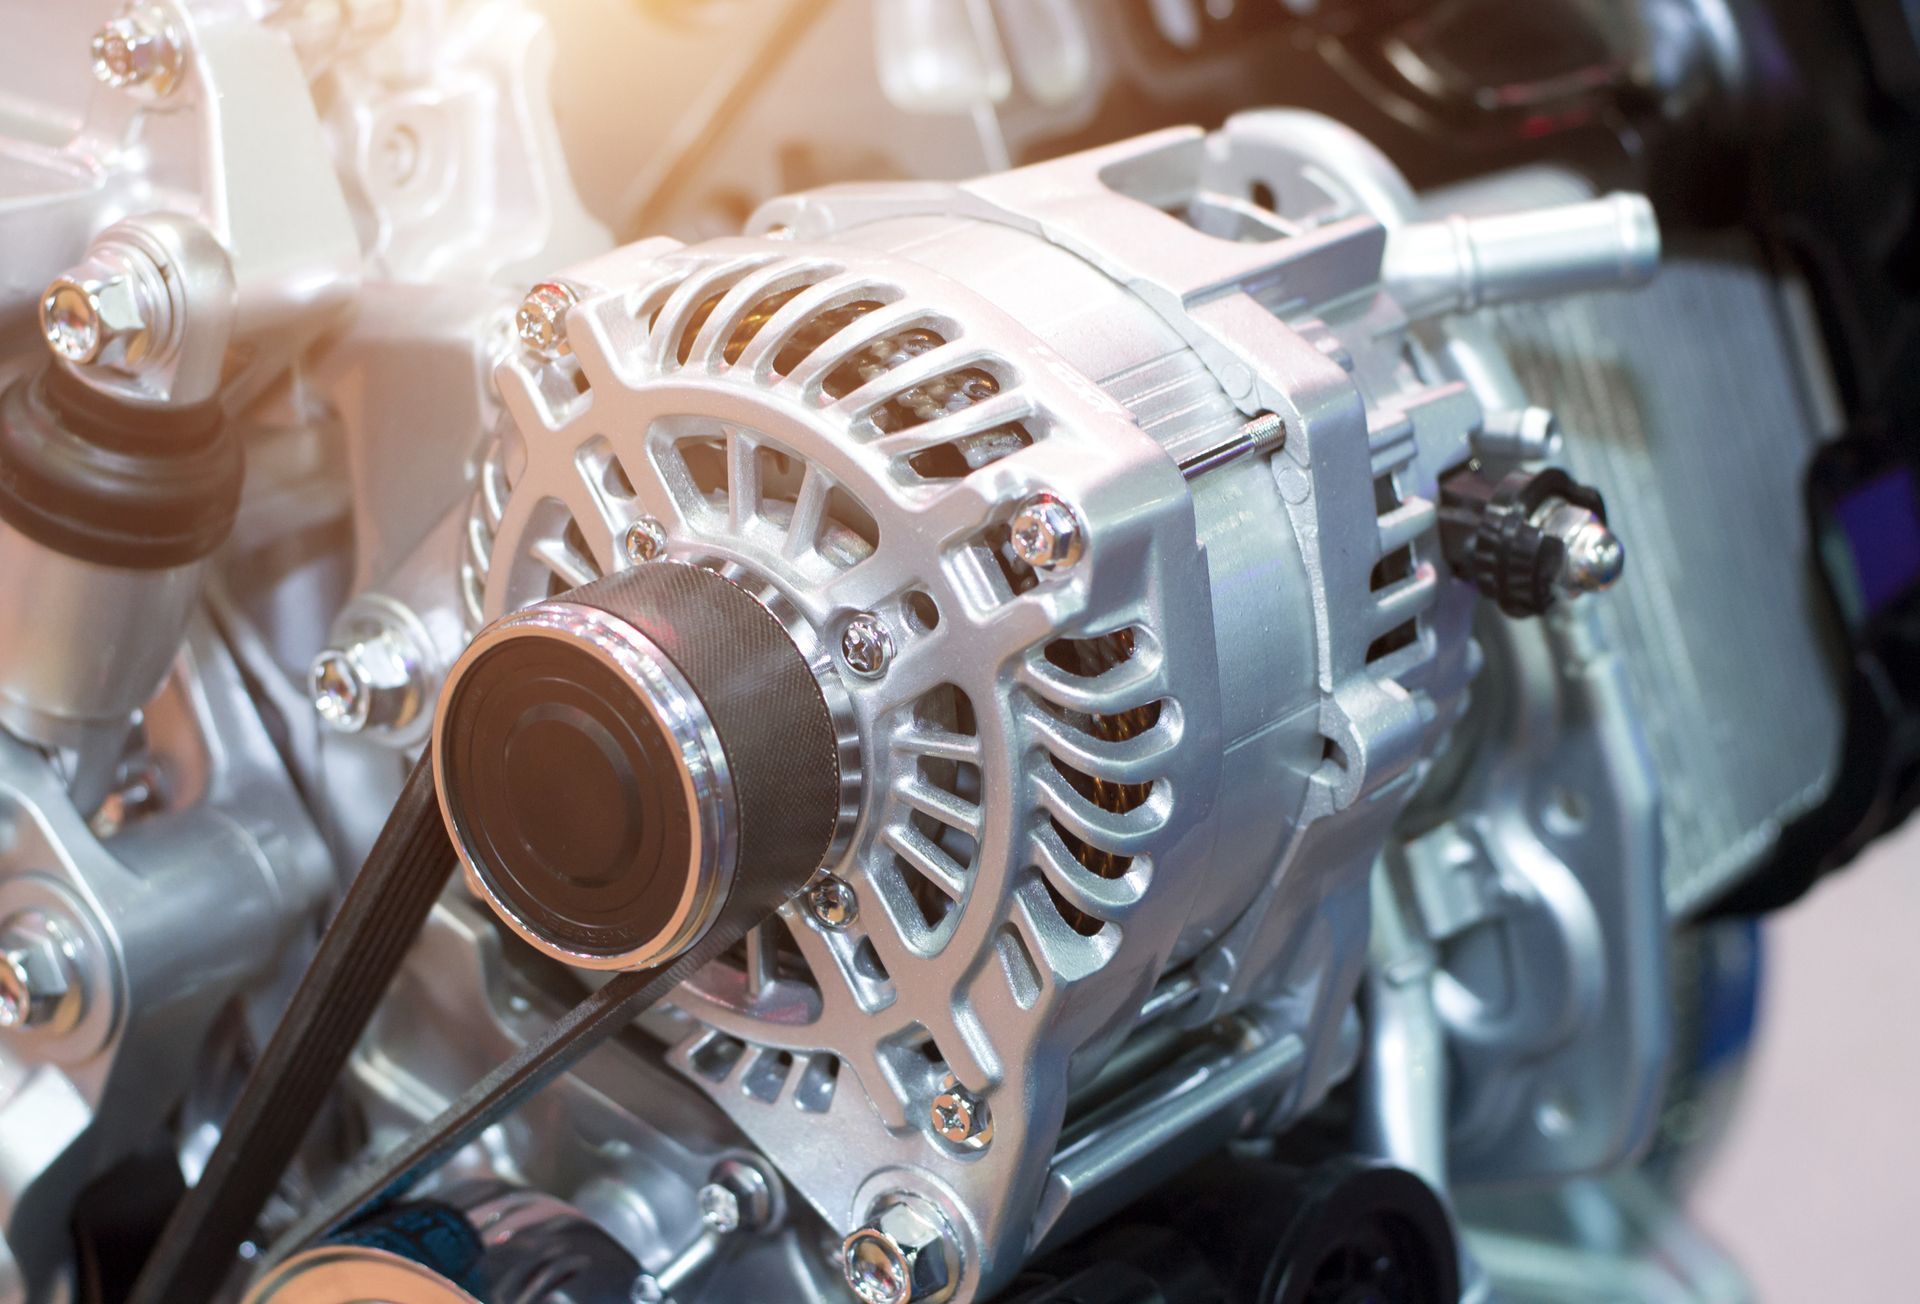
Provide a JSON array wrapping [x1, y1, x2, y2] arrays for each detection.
[[438, 563, 839, 956]]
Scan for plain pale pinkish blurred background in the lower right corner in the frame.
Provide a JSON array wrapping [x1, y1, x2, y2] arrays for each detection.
[[1692, 824, 1920, 1304]]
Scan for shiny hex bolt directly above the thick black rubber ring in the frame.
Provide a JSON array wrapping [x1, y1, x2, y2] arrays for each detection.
[[40, 240, 173, 371]]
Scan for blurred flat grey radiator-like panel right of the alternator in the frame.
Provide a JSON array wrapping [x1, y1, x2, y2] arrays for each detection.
[[1488, 236, 1843, 914]]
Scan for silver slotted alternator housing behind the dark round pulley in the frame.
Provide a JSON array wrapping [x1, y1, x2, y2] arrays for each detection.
[[465, 111, 1657, 1302]]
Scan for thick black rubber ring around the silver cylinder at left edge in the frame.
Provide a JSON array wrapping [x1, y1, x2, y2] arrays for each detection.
[[0, 365, 246, 570]]
